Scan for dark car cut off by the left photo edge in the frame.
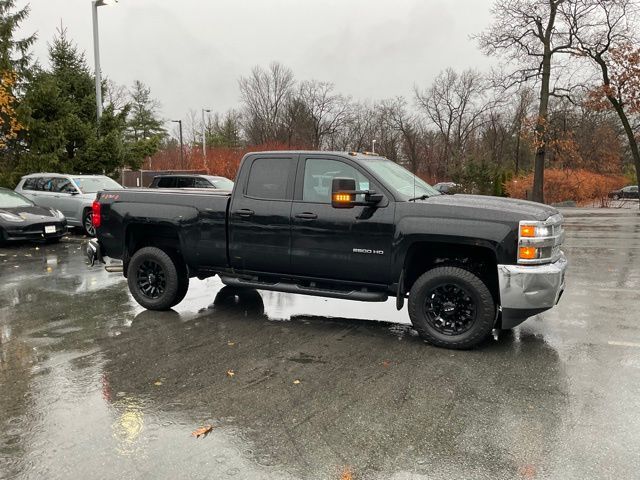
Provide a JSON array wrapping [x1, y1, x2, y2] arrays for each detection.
[[0, 188, 67, 246]]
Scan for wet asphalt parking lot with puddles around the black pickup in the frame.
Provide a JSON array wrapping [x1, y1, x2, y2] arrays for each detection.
[[0, 209, 640, 479]]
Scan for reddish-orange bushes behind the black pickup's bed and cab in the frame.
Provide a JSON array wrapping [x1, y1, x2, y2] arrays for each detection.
[[142, 143, 298, 180]]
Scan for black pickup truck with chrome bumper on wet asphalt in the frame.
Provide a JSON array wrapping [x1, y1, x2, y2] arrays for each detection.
[[87, 151, 567, 348]]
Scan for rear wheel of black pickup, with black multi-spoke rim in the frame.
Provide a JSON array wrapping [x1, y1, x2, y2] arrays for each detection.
[[127, 247, 189, 310]]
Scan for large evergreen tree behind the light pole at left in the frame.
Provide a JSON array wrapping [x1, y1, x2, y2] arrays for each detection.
[[20, 30, 130, 174]]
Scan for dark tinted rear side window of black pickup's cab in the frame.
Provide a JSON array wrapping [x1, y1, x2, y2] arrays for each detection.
[[246, 158, 295, 200]]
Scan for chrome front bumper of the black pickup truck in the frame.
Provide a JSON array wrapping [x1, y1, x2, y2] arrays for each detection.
[[498, 252, 567, 328]]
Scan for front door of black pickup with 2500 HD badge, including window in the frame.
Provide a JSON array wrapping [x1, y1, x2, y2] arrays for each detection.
[[291, 157, 394, 283]]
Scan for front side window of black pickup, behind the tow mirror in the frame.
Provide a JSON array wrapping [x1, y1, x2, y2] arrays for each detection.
[[302, 158, 369, 203]]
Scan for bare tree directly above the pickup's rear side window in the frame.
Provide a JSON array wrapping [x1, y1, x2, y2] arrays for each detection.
[[238, 62, 295, 144]]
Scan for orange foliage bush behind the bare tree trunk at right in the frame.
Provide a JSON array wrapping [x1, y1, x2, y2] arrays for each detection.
[[505, 168, 626, 204]]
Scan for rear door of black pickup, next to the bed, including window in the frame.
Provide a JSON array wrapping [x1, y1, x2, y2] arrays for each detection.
[[229, 154, 298, 273]]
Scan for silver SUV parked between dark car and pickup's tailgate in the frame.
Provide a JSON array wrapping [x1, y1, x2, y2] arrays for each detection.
[[16, 173, 122, 237]]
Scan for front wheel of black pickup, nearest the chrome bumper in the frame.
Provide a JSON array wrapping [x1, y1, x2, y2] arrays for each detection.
[[409, 267, 496, 349]]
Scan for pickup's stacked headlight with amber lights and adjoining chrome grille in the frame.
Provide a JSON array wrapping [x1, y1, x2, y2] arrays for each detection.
[[518, 214, 564, 264]]
